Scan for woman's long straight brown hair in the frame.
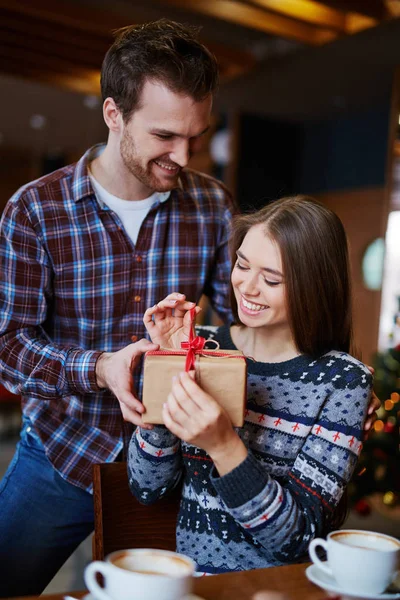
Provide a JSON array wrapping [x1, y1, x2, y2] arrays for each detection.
[[231, 196, 352, 356]]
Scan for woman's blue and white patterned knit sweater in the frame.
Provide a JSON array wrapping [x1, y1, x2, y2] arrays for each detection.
[[128, 326, 372, 573]]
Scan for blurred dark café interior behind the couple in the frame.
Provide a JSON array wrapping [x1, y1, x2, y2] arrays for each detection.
[[0, 0, 400, 592]]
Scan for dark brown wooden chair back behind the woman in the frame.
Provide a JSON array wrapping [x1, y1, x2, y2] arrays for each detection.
[[92, 462, 181, 560]]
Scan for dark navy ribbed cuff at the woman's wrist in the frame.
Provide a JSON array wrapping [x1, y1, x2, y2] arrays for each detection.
[[210, 451, 270, 508]]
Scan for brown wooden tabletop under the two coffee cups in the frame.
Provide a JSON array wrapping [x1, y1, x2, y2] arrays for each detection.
[[13, 564, 326, 600]]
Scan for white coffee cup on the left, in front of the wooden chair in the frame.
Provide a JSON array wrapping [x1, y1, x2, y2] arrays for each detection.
[[84, 548, 196, 600]]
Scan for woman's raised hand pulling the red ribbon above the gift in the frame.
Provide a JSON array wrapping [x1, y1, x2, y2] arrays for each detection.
[[143, 292, 201, 349]]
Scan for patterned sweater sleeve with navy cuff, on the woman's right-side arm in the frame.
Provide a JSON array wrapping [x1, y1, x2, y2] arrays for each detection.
[[211, 374, 372, 563]]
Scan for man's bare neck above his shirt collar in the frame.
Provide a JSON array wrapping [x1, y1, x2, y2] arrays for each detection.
[[90, 144, 154, 201]]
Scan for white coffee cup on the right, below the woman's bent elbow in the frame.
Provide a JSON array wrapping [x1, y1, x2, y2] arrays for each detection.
[[309, 529, 400, 594]]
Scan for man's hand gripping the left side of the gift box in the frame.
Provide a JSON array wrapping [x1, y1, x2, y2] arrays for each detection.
[[96, 339, 159, 429]]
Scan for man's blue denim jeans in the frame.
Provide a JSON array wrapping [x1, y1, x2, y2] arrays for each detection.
[[0, 420, 93, 598]]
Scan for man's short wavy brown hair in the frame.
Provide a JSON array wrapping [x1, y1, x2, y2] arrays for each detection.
[[101, 19, 218, 122]]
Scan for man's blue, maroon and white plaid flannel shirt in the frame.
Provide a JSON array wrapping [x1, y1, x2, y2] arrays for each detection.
[[0, 149, 233, 491]]
